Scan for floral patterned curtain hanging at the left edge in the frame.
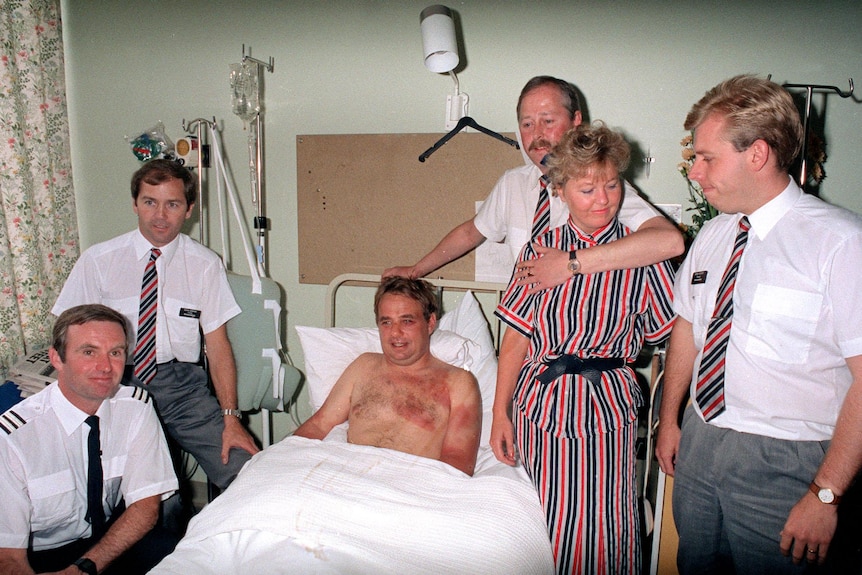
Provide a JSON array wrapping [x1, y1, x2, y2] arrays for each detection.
[[0, 0, 79, 383]]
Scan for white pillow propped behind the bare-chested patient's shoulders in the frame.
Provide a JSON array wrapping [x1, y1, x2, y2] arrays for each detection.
[[296, 292, 497, 445]]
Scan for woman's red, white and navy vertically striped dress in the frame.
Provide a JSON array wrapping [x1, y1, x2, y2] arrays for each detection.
[[495, 219, 674, 574]]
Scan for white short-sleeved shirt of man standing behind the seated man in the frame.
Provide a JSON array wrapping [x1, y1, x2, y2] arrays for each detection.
[[51, 229, 242, 363]]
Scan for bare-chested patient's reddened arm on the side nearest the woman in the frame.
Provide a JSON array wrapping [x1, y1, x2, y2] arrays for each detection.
[[440, 369, 482, 476]]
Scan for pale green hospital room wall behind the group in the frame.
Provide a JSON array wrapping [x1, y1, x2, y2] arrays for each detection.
[[63, 0, 862, 446]]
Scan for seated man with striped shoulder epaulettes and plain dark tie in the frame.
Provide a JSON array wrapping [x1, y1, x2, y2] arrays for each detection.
[[0, 305, 177, 574]]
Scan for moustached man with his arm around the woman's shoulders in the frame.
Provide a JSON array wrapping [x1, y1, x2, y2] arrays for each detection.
[[383, 76, 684, 290]]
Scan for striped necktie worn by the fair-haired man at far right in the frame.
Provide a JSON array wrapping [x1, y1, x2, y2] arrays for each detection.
[[695, 216, 751, 421]]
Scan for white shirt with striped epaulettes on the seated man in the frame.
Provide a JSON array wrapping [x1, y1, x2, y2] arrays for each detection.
[[0, 383, 177, 551]]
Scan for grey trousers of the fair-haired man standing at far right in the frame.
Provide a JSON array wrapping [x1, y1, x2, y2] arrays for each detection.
[[673, 406, 829, 575]]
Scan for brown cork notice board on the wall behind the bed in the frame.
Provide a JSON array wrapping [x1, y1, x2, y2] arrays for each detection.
[[296, 136, 524, 284]]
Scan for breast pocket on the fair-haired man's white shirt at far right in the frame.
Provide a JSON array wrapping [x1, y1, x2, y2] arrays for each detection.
[[745, 285, 823, 365]]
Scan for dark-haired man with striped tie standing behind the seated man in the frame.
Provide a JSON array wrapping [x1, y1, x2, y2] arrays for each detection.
[[52, 160, 258, 488]]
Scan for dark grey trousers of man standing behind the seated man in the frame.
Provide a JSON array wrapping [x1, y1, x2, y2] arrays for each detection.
[[123, 362, 251, 489]]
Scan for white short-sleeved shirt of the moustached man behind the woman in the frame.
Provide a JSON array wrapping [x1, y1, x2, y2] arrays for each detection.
[[473, 164, 661, 265]]
